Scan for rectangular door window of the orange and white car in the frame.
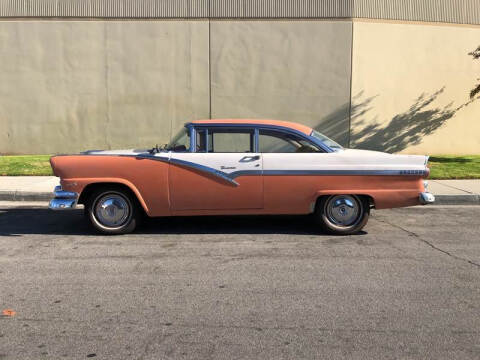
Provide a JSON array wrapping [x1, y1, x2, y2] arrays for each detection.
[[208, 128, 255, 153]]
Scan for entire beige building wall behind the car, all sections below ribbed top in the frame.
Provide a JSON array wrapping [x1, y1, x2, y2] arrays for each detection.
[[0, 13, 480, 154]]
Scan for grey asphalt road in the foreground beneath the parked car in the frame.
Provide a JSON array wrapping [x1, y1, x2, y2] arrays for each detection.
[[0, 205, 480, 360]]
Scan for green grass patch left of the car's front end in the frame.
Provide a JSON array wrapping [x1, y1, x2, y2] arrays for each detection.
[[0, 155, 53, 176]]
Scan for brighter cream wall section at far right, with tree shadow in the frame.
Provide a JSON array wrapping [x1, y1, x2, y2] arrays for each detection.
[[352, 21, 480, 154]]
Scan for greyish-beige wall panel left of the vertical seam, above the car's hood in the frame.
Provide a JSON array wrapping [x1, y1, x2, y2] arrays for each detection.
[[0, 21, 209, 154]]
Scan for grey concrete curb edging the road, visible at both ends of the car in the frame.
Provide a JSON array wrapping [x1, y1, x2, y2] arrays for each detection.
[[0, 191, 480, 206]]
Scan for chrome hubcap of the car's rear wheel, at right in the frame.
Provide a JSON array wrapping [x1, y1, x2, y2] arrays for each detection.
[[325, 195, 363, 228]]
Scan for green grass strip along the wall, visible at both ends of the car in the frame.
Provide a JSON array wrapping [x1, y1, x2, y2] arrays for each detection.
[[0, 155, 480, 179]]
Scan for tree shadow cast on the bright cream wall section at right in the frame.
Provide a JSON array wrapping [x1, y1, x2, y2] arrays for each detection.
[[351, 87, 475, 153]]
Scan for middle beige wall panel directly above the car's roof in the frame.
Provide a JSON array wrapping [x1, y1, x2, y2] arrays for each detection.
[[210, 20, 352, 144]]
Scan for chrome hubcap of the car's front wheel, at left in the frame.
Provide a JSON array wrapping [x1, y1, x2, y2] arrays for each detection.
[[95, 194, 130, 227]]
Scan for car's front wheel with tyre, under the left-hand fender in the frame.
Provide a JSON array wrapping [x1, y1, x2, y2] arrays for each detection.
[[85, 188, 140, 234]]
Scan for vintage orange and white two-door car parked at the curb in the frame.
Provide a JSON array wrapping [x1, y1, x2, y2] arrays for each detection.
[[50, 119, 434, 234]]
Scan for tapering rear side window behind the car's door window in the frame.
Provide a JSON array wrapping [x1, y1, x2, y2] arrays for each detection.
[[259, 130, 323, 153]]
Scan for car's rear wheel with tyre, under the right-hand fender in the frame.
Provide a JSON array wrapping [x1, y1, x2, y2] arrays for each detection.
[[315, 195, 370, 235]]
